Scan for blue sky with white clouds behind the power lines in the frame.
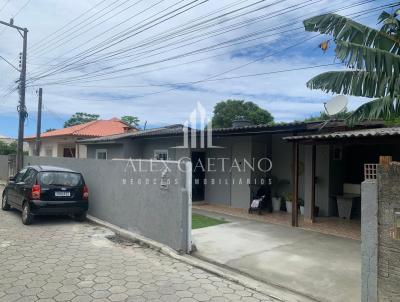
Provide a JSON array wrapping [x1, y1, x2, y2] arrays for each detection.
[[0, 0, 389, 135]]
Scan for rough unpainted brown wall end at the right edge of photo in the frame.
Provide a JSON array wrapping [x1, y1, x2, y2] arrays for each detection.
[[377, 163, 400, 301]]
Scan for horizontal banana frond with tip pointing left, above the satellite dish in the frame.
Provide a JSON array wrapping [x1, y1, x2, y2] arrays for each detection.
[[307, 71, 400, 98]]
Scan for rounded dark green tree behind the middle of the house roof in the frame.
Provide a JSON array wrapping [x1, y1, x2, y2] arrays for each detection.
[[212, 100, 274, 128]]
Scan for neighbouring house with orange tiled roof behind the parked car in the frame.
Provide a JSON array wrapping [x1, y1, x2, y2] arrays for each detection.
[[25, 118, 137, 158]]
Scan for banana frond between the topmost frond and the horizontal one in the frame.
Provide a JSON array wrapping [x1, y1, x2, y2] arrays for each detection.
[[335, 41, 400, 77]]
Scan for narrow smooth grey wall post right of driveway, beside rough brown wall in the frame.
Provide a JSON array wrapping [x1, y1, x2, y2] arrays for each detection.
[[361, 180, 378, 302]]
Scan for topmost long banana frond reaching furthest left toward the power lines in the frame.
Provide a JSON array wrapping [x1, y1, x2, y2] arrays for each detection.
[[303, 14, 400, 54]]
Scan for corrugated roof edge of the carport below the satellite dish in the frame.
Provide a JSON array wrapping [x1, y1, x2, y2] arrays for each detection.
[[283, 126, 400, 141]]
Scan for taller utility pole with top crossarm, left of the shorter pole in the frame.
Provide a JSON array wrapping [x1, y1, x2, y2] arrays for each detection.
[[0, 19, 28, 171]]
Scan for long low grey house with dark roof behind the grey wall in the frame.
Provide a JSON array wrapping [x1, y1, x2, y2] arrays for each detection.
[[80, 121, 392, 224]]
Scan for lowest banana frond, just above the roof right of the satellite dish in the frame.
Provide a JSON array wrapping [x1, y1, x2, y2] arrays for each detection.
[[347, 96, 400, 124]]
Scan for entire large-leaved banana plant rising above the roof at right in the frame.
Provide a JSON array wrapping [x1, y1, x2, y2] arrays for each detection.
[[304, 10, 400, 122]]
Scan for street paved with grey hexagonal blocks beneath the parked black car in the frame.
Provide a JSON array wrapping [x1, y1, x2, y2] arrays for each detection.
[[0, 206, 272, 302]]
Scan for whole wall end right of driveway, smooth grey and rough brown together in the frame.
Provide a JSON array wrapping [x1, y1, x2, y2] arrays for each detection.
[[361, 160, 400, 302]]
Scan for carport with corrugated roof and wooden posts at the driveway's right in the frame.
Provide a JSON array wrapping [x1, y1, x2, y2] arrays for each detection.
[[284, 127, 400, 227]]
